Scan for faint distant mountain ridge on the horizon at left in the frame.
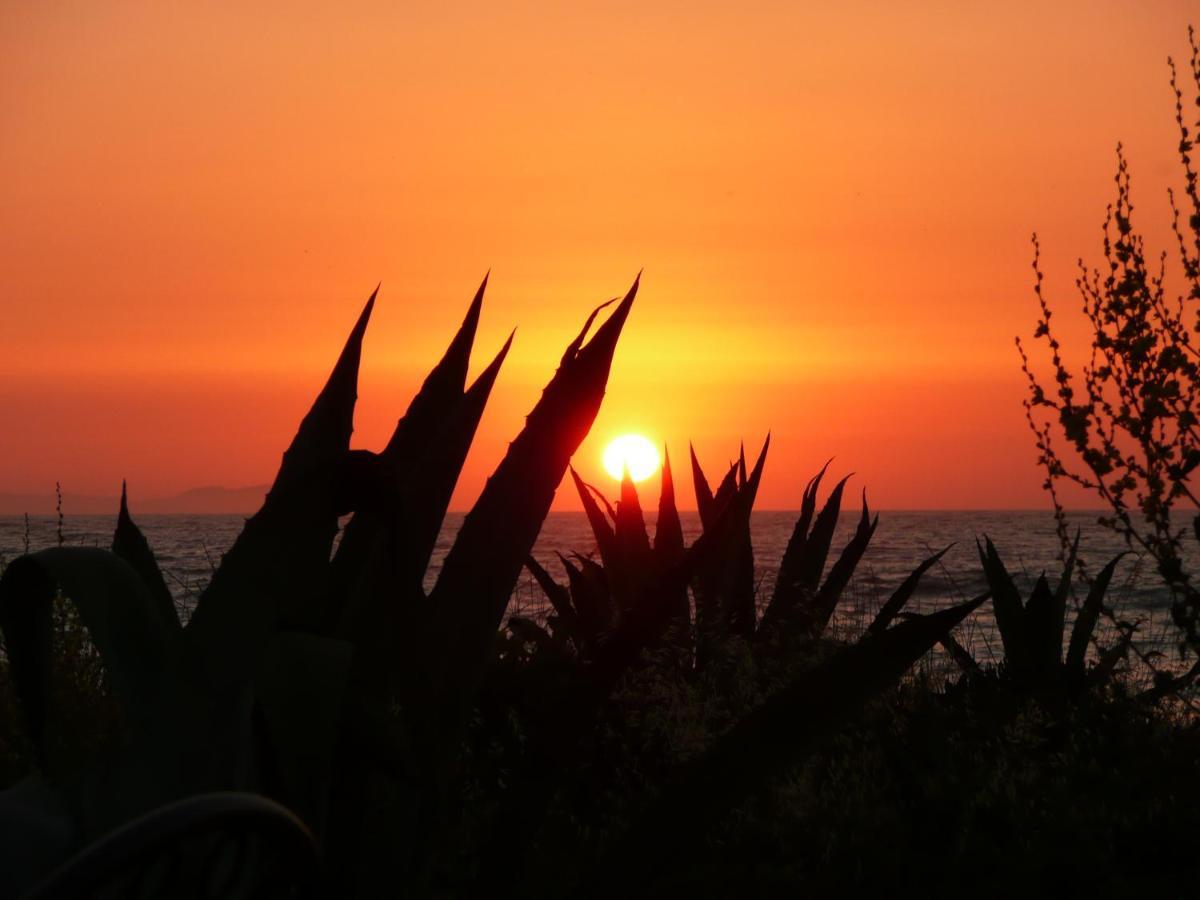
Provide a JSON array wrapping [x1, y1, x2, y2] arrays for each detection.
[[0, 485, 268, 516]]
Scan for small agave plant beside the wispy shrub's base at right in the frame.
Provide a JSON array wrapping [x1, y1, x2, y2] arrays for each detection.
[[969, 534, 1129, 694]]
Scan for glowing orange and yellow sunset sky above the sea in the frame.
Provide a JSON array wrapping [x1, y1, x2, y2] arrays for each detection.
[[0, 0, 1200, 509]]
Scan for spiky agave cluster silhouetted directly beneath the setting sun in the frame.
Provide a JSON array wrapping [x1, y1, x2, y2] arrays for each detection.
[[523, 448, 964, 667]]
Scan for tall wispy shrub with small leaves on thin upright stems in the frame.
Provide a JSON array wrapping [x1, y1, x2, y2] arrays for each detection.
[[1016, 29, 1200, 648]]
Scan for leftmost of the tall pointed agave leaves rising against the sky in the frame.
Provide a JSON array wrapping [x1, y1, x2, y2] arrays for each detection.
[[185, 288, 378, 690]]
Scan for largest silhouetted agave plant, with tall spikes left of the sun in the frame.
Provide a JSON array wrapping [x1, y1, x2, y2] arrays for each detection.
[[0, 278, 637, 895]]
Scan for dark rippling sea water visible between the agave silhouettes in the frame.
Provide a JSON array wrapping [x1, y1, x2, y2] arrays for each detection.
[[0, 509, 1200, 681]]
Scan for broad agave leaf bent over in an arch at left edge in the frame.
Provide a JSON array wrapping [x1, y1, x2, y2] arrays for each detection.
[[0, 547, 174, 764]]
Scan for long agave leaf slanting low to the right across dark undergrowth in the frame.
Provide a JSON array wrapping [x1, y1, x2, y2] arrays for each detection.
[[593, 598, 983, 896]]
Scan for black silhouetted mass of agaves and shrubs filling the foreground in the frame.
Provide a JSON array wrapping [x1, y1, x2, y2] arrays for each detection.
[[7, 24, 1200, 898]]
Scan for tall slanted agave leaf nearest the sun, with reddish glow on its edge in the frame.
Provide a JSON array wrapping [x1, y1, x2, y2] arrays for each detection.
[[431, 281, 638, 721]]
